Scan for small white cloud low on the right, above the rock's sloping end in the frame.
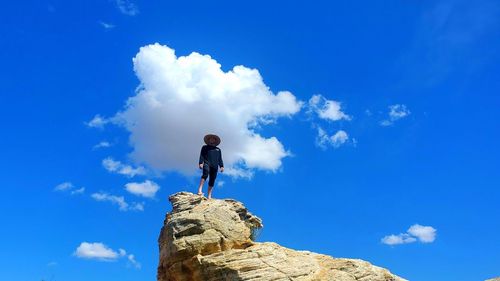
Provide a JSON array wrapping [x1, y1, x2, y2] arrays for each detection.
[[381, 224, 436, 245]]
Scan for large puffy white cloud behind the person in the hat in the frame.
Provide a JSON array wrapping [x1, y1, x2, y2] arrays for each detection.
[[112, 44, 302, 177]]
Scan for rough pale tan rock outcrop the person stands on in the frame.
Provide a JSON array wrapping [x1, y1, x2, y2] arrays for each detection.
[[157, 192, 404, 281]]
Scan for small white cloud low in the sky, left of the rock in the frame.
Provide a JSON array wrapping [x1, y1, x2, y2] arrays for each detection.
[[73, 242, 141, 268]]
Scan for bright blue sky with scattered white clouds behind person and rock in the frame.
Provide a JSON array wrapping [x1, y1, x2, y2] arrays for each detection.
[[0, 0, 500, 281]]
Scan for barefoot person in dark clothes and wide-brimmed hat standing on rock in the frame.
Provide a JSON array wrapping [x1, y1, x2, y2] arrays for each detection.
[[198, 134, 224, 199]]
